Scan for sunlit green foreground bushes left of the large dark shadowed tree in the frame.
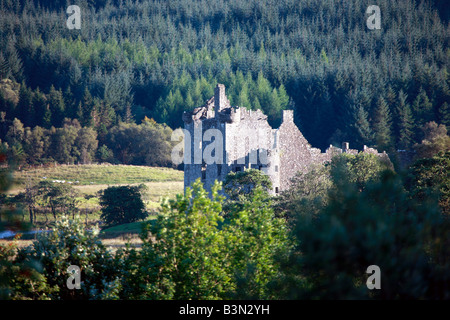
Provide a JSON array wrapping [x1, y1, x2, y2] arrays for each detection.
[[0, 181, 289, 299]]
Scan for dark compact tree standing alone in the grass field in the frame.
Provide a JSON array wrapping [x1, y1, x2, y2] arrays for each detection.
[[100, 186, 148, 225]]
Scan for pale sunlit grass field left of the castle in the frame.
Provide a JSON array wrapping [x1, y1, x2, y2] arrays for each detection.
[[2, 164, 184, 248]]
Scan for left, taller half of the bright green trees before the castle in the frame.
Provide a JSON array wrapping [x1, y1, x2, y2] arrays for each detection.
[[133, 180, 231, 300]]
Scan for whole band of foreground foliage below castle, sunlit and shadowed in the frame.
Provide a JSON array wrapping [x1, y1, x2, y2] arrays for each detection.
[[0, 153, 450, 299]]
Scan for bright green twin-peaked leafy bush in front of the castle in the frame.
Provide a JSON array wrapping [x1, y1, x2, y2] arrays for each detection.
[[119, 180, 288, 299]]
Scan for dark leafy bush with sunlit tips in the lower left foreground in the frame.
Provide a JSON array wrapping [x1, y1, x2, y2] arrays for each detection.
[[14, 216, 119, 300]]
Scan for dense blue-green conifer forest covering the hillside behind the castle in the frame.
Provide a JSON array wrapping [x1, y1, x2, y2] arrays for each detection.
[[0, 0, 450, 168]]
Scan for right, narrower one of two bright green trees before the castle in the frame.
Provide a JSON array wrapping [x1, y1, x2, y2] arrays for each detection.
[[224, 185, 293, 299]]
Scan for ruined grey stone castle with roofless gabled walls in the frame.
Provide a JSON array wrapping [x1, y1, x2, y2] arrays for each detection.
[[183, 84, 387, 195]]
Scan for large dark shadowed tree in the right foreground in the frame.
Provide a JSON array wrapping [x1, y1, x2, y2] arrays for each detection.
[[280, 168, 448, 299]]
